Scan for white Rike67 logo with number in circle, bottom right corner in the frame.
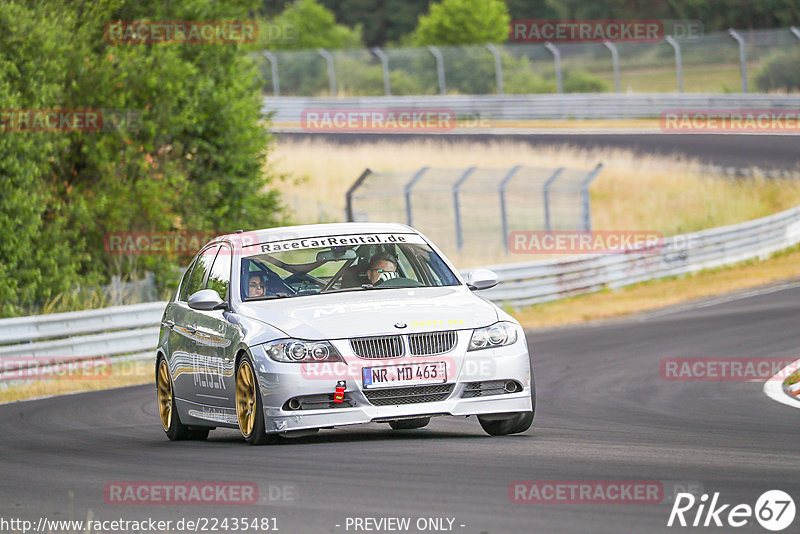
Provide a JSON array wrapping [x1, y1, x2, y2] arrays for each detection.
[[667, 490, 795, 532]]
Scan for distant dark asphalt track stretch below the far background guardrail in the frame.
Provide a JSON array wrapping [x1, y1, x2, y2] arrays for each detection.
[[278, 130, 800, 171]]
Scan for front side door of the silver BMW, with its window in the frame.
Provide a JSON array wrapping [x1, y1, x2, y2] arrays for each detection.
[[194, 244, 239, 408]]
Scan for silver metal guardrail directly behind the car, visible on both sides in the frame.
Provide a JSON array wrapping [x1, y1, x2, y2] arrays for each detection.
[[0, 206, 800, 382]]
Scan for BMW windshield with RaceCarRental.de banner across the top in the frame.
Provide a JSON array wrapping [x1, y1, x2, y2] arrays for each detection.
[[241, 234, 459, 300]]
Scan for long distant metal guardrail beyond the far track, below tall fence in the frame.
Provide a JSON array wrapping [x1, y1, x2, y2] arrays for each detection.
[[262, 93, 800, 124]]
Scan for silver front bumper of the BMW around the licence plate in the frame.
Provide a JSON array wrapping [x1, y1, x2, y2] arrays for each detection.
[[252, 336, 533, 432]]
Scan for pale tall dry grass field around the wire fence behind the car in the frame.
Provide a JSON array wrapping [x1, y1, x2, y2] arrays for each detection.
[[270, 136, 800, 268]]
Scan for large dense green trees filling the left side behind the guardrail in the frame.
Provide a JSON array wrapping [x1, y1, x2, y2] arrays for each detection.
[[0, 0, 284, 315]]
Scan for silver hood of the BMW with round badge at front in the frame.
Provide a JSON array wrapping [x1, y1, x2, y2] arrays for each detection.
[[237, 286, 498, 339]]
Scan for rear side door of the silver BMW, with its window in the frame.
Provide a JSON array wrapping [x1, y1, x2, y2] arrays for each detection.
[[170, 245, 219, 402]]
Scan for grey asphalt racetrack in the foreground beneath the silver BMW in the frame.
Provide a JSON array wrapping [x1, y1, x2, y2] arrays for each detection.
[[0, 282, 800, 534]]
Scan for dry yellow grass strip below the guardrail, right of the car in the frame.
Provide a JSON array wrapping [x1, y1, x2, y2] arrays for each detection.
[[509, 247, 800, 328]]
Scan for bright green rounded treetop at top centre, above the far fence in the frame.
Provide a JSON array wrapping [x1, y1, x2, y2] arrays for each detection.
[[413, 0, 511, 46]]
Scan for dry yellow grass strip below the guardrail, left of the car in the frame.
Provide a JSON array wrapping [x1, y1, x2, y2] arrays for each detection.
[[0, 360, 155, 402]]
